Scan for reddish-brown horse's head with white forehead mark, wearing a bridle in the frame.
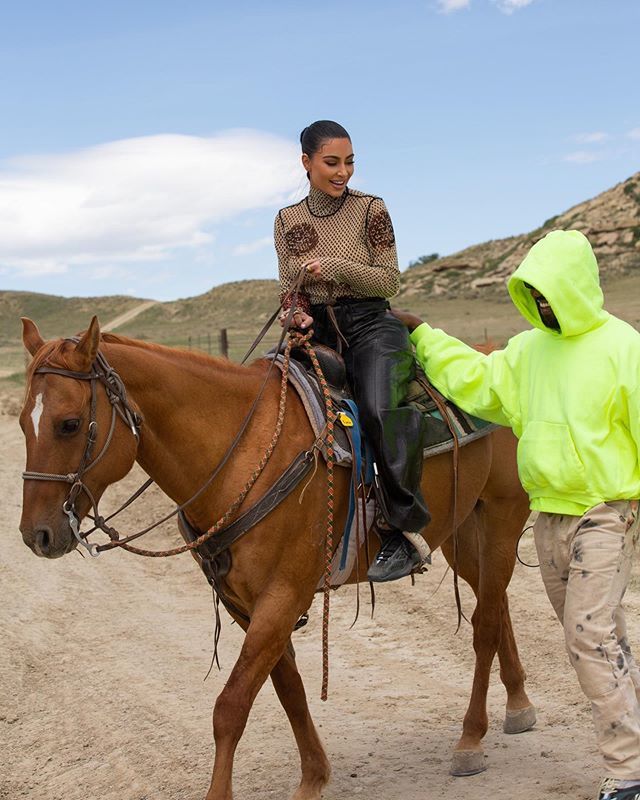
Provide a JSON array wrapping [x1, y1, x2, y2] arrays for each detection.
[[20, 317, 137, 558]]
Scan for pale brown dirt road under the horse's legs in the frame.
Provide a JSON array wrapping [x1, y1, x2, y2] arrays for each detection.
[[0, 415, 640, 800]]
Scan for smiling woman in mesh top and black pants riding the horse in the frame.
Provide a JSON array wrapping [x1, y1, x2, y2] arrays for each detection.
[[274, 120, 430, 581]]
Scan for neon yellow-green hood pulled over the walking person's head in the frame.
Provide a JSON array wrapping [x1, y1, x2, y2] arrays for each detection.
[[507, 231, 608, 336]]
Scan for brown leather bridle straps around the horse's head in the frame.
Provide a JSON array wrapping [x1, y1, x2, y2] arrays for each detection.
[[22, 338, 141, 557]]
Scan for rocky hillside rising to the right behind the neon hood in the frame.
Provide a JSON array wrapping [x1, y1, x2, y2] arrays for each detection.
[[400, 172, 640, 305]]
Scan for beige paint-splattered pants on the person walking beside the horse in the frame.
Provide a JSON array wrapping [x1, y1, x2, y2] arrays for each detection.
[[534, 500, 640, 780]]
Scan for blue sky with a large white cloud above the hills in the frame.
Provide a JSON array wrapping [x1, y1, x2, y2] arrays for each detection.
[[0, 0, 640, 300]]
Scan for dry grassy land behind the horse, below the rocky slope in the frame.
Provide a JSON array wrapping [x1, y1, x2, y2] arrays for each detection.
[[7, 276, 640, 391]]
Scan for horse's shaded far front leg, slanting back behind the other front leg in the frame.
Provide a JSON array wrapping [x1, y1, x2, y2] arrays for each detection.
[[271, 641, 330, 800]]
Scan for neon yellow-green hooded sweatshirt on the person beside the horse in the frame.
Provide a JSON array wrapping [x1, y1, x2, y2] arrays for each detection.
[[411, 231, 640, 515]]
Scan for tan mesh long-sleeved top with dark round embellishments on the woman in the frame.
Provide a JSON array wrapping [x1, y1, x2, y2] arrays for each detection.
[[274, 187, 400, 308]]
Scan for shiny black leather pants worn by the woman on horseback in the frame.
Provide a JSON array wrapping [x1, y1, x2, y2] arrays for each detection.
[[311, 297, 430, 531]]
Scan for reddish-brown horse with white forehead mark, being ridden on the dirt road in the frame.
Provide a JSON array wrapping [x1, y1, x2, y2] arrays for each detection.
[[20, 317, 535, 800]]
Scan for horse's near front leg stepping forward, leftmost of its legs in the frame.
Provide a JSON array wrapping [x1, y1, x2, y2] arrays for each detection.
[[206, 587, 304, 800]]
